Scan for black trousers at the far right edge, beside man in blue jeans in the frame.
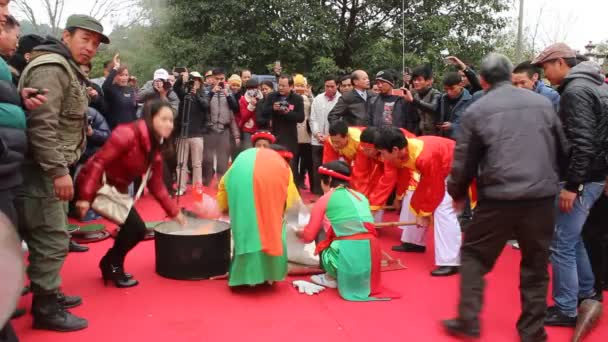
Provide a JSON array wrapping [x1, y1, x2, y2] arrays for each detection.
[[583, 195, 608, 293]]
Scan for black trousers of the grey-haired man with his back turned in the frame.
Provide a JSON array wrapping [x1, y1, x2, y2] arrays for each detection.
[[458, 197, 555, 341]]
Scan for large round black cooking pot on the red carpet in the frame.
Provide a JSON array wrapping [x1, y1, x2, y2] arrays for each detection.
[[154, 217, 230, 280]]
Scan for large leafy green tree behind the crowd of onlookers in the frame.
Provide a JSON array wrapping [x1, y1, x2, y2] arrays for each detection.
[[156, 0, 506, 85]]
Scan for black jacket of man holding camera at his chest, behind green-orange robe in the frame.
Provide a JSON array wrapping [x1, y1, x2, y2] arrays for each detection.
[[262, 91, 304, 152]]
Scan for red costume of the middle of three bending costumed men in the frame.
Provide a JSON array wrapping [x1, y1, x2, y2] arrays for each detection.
[[351, 129, 417, 210]]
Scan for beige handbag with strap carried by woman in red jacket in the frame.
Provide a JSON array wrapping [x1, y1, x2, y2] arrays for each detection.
[[91, 165, 152, 225]]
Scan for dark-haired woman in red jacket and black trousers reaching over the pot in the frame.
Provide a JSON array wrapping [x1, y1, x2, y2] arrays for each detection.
[[76, 100, 186, 287]]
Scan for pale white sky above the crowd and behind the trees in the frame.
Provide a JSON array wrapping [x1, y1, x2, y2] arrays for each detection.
[[13, 0, 608, 51]]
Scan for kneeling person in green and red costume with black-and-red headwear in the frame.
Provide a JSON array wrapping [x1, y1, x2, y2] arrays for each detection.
[[296, 160, 392, 301]]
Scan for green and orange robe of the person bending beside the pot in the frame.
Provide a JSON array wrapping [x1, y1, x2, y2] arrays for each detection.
[[217, 148, 300, 286]]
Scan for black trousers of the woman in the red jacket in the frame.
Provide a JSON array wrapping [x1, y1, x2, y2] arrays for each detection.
[[106, 208, 147, 265]]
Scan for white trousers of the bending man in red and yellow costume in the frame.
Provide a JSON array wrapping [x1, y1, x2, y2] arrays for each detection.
[[399, 190, 462, 266]]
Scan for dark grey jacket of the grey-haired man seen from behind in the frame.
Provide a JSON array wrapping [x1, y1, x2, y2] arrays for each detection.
[[448, 83, 567, 200]]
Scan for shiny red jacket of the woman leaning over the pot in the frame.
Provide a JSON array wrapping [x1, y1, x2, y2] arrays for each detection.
[[76, 120, 179, 217]]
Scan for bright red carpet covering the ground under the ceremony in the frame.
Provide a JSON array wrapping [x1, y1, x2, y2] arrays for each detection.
[[13, 190, 608, 342]]
